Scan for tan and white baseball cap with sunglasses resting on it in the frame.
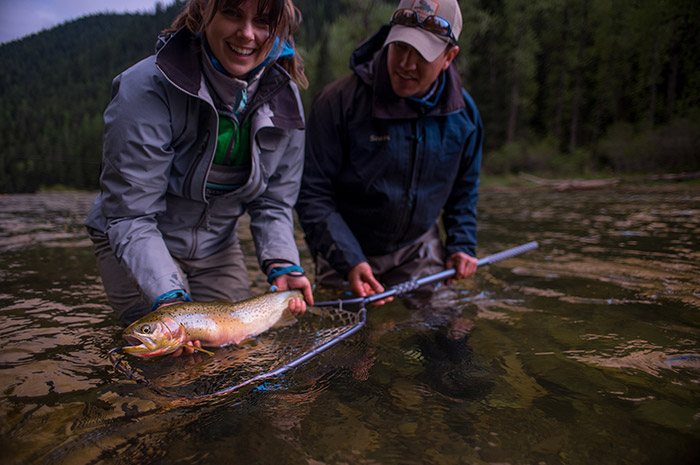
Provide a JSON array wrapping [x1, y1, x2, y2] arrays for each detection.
[[384, 0, 462, 62]]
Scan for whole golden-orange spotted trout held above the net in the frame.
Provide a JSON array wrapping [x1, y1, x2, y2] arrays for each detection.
[[123, 290, 303, 357]]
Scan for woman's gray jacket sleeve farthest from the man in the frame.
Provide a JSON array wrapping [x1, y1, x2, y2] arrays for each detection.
[[100, 62, 185, 302]]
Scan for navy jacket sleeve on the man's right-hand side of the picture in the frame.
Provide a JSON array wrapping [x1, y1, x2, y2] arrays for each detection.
[[442, 90, 484, 257]]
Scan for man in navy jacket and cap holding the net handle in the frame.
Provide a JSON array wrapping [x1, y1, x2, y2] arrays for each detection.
[[296, 0, 483, 303]]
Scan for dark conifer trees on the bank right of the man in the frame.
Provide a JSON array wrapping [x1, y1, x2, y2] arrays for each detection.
[[460, 0, 700, 174]]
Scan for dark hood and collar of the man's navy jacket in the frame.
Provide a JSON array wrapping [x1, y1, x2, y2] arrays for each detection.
[[350, 26, 466, 119]]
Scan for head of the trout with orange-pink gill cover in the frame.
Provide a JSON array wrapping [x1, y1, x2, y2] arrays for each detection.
[[122, 315, 186, 357]]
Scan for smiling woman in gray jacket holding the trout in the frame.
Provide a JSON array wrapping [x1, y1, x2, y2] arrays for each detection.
[[86, 0, 313, 344]]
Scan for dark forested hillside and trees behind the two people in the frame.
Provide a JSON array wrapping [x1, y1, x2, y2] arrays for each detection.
[[0, 0, 700, 192]]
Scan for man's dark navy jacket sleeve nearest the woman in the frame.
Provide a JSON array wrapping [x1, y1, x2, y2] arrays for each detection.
[[296, 84, 367, 277]]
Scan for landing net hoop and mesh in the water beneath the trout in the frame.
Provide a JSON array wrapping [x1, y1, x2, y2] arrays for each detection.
[[109, 301, 366, 399]]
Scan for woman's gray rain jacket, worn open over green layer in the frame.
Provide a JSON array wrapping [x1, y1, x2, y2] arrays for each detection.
[[86, 29, 304, 301]]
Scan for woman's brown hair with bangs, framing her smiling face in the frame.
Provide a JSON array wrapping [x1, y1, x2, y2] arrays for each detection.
[[163, 0, 309, 89]]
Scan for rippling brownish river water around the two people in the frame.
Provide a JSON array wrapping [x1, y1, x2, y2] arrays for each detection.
[[0, 185, 700, 465]]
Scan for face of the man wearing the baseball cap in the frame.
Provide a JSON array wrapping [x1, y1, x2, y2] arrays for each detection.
[[387, 42, 459, 98]]
